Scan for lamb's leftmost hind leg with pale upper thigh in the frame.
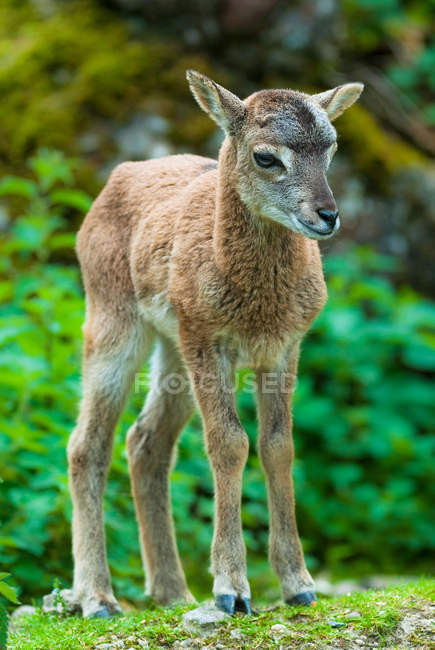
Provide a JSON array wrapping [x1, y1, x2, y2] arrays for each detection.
[[68, 308, 152, 617]]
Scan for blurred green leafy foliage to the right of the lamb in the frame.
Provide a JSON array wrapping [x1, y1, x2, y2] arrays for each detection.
[[295, 250, 435, 570]]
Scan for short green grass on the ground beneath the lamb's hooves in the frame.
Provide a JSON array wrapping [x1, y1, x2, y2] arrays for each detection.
[[8, 578, 435, 650]]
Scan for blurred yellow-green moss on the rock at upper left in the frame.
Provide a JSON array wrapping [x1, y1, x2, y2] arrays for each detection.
[[0, 1, 218, 190]]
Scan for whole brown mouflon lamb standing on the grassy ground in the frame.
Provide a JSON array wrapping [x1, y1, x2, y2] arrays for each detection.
[[68, 71, 363, 617]]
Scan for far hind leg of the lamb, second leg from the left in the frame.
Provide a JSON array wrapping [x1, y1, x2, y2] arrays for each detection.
[[127, 338, 194, 604]]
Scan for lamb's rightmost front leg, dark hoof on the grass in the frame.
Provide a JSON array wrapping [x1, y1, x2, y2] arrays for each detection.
[[257, 353, 316, 605]]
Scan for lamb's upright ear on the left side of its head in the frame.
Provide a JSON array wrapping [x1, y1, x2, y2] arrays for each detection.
[[186, 70, 246, 136]]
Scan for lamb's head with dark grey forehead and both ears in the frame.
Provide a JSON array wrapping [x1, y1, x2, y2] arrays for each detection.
[[187, 70, 363, 239]]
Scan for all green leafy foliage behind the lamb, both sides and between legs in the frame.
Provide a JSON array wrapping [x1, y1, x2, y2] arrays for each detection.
[[0, 151, 435, 599]]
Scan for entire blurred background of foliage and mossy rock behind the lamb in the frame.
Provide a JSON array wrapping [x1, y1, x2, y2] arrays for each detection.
[[0, 0, 435, 602]]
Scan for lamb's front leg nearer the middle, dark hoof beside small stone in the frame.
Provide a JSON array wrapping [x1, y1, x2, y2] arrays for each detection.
[[183, 335, 251, 614]]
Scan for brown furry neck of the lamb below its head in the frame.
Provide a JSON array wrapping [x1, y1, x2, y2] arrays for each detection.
[[213, 140, 307, 288]]
